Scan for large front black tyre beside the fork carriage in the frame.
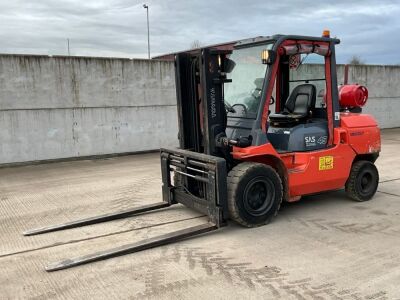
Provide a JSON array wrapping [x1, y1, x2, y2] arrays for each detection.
[[227, 162, 283, 227]]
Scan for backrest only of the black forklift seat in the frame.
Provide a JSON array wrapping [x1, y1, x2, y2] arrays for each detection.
[[285, 83, 317, 115]]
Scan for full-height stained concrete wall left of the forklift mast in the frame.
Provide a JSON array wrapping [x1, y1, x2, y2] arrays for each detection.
[[0, 55, 177, 164]]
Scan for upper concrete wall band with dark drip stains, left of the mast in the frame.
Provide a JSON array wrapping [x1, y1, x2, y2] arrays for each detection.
[[0, 55, 176, 110]]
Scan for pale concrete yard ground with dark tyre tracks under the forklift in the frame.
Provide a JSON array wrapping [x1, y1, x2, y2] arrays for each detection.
[[0, 129, 400, 300]]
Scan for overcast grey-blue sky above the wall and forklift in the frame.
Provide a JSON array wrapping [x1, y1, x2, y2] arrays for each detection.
[[0, 0, 400, 64]]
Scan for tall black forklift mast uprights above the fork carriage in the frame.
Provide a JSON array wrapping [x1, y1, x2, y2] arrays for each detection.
[[175, 48, 231, 158]]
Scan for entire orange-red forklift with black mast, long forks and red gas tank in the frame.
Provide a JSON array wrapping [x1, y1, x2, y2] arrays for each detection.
[[24, 31, 381, 271]]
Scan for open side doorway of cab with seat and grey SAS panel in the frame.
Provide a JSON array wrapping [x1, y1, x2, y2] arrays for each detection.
[[267, 48, 329, 152]]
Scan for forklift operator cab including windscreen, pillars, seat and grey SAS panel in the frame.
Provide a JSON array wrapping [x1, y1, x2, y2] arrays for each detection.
[[224, 36, 338, 153]]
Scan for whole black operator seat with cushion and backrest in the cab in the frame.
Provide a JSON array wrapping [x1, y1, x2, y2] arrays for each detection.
[[269, 83, 316, 125]]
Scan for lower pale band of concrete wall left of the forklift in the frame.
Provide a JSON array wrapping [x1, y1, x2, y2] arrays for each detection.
[[0, 105, 177, 164]]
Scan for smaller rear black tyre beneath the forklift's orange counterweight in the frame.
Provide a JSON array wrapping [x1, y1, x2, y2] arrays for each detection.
[[345, 160, 379, 202]]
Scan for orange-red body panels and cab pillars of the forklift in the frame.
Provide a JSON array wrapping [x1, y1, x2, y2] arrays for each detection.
[[232, 41, 381, 201]]
